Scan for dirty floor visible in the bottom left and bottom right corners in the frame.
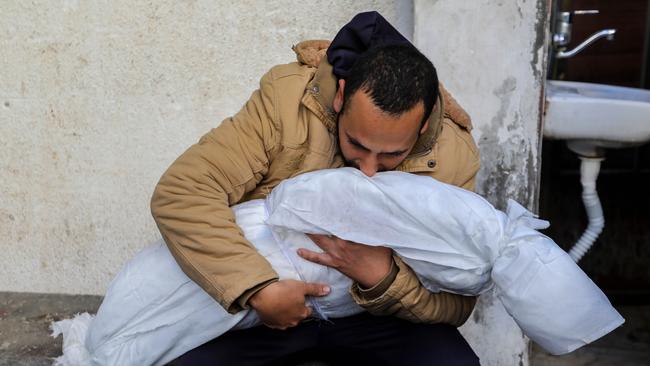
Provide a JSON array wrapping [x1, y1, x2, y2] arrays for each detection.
[[0, 292, 650, 366]]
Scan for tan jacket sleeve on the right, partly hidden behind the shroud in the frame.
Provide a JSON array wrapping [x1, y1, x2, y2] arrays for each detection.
[[350, 119, 480, 326]]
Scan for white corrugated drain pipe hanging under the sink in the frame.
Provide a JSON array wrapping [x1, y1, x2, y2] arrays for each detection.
[[569, 156, 605, 262]]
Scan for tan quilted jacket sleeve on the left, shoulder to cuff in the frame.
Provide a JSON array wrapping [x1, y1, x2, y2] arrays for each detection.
[[151, 70, 279, 313]]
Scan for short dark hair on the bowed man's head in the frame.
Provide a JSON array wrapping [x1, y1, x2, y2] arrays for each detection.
[[343, 45, 438, 125]]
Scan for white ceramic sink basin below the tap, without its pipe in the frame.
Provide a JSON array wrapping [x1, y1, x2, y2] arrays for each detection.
[[544, 80, 650, 152]]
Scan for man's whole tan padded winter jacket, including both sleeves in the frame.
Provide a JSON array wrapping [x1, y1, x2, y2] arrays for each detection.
[[151, 41, 479, 325]]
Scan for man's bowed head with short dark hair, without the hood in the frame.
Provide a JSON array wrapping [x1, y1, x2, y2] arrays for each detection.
[[333, 45, 438, 176]]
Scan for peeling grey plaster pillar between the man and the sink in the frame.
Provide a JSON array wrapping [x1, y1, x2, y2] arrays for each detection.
[[414, 0, 548, 366]]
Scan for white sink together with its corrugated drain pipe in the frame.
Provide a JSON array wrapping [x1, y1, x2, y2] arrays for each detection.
[[544, 80, 650, 262]]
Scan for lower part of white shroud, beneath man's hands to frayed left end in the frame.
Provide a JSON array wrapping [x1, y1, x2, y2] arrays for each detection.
[[55, 200, 363, 366]]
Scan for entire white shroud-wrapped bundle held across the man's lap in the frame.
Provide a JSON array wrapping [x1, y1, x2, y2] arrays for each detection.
[[52, 169, 624, 365]]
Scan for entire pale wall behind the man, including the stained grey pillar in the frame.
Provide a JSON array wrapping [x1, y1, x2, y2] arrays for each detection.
[[0, 0, 546, 365]]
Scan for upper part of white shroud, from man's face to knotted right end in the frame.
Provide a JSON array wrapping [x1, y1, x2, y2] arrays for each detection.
[[267, 168, 624, 354]]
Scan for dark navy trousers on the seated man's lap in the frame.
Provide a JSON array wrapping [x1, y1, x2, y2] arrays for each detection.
[[175, 313, 479, 366]]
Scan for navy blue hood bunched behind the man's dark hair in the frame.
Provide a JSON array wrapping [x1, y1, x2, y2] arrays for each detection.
[[327, 11, 415, 78]]
